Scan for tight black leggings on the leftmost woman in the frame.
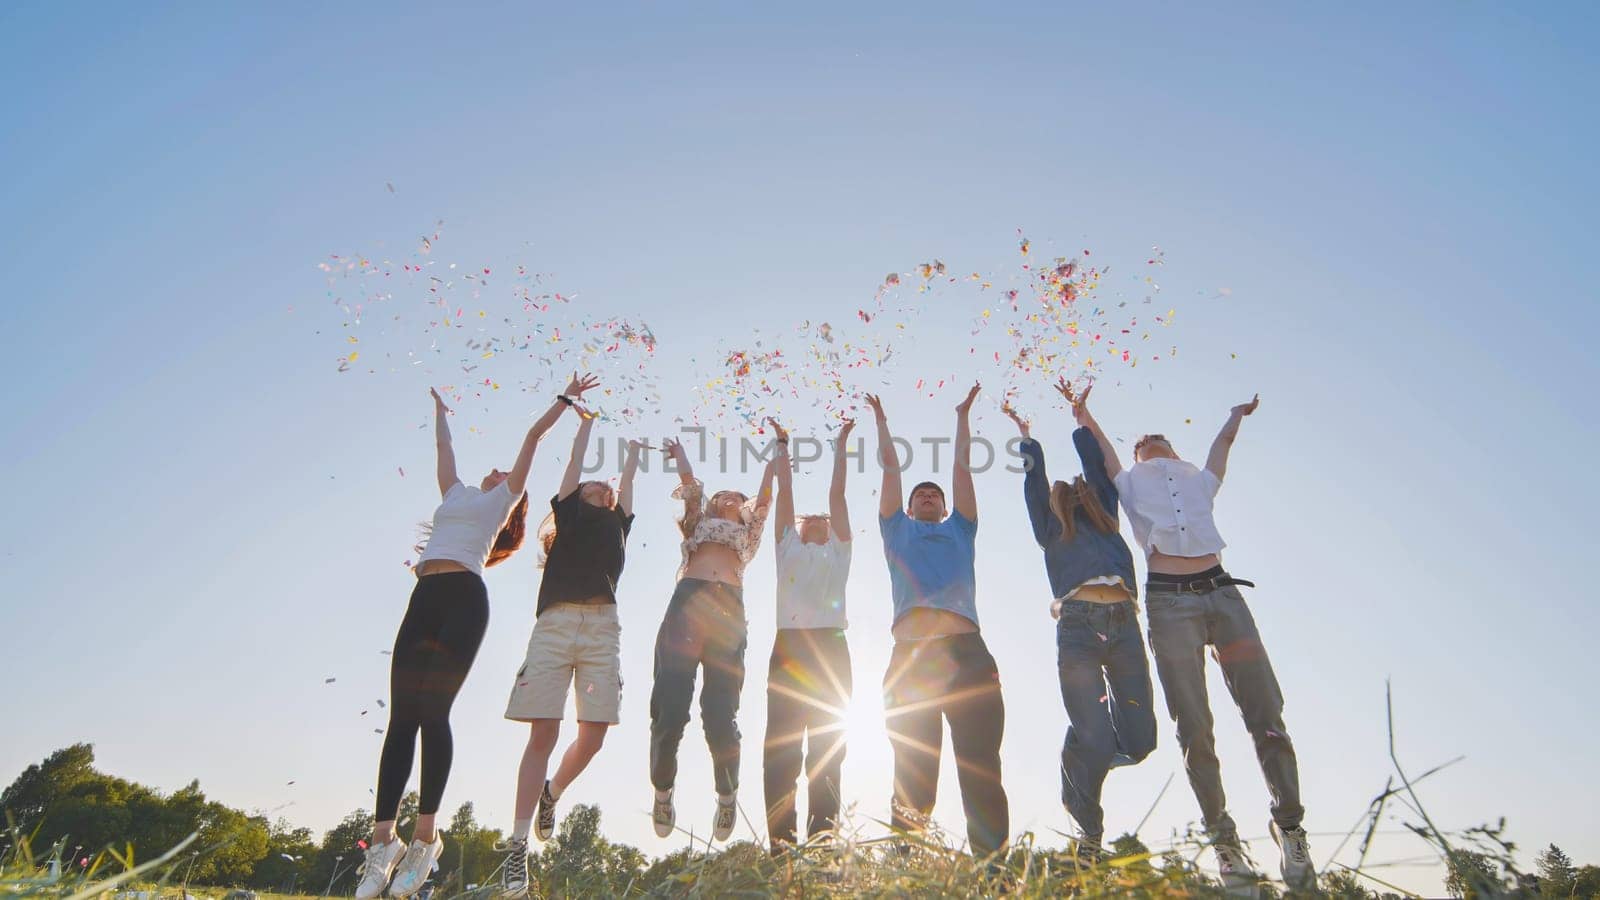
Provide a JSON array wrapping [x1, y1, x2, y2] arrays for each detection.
[[376, 572, 490, 822]]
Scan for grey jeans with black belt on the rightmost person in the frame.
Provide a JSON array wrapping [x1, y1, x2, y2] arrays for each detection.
[[1146, 586, 1306, 841]]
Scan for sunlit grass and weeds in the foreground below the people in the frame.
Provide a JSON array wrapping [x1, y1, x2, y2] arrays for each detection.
[[0, 685, 1518, 900]]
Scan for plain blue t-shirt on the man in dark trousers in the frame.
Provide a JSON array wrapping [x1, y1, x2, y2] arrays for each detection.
[[878, 509, 978, 625]]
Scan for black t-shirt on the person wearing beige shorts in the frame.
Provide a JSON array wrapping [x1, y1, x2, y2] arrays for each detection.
[[534, 490, 634, 617]]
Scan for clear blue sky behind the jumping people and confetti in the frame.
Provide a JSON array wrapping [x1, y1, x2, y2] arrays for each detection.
[[0, 3, 1600, 892]]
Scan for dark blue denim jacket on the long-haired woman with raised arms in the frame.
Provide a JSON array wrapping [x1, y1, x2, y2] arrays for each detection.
[[1021, 428, 1138, 599]]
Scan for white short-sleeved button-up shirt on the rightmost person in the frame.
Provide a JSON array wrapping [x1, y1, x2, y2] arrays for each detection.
[[1115, 456, 1227, 556]]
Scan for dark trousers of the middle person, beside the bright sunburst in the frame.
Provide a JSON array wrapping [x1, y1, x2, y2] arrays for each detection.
[[762, 628, 851, 850]]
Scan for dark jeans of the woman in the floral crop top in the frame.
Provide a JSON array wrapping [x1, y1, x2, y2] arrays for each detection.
[[650, 578, 746, 794]]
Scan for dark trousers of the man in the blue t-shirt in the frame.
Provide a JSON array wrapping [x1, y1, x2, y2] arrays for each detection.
[[883, 633, 1011, 857]]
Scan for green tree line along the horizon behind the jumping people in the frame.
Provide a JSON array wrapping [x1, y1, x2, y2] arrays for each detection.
[[0, 743, 1600, 900]]
